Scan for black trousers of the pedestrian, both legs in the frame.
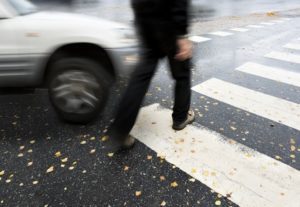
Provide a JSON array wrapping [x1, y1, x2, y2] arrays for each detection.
[[108, 26, 191, 141]]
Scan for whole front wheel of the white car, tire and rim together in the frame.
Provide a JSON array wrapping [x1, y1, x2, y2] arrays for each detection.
[[48, 58, 112, 124]]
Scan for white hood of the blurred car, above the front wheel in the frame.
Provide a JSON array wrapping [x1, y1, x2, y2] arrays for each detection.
[[22, 11, 137, 48]]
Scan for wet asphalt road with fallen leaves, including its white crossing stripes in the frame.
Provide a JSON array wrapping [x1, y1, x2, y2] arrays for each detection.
[[0, 1, 300, 207]]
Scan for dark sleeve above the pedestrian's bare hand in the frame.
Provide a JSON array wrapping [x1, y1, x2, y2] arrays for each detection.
[[171, 0, 190, 36]]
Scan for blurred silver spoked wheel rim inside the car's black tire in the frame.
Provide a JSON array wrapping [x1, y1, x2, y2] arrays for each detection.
[[50, 70, 101, 114]]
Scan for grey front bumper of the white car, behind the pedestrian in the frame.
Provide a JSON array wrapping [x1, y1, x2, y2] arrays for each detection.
[[107, 47, 139, 76]]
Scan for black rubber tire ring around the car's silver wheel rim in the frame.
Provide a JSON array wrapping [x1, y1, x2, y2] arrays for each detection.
[[47, 57, 112, 124]]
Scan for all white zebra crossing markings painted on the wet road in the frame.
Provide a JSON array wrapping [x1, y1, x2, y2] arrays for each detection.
[[131, 27, 300, 207]]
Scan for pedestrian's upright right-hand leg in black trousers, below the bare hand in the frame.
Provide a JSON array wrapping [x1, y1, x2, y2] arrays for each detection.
[[168, 54, 191, 123]]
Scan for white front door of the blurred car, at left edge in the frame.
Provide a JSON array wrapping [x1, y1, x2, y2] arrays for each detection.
[[0, 4, 39, 87]]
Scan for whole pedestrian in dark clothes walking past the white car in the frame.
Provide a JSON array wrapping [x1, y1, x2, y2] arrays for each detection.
[[108, 0, 195, 148]]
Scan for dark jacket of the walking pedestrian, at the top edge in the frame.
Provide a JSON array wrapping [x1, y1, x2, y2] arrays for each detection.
[[131, 0, 189, 36]]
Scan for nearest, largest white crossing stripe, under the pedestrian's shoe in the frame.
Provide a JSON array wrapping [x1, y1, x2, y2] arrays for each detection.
[[131, 104, 300, 207]]
